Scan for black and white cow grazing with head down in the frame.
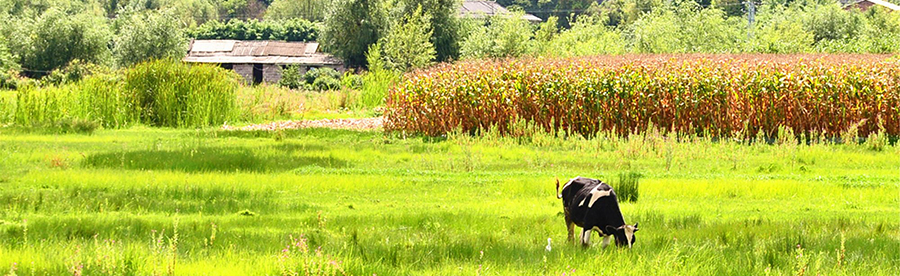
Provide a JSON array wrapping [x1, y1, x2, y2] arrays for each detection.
[[556, 177, 638, 248]]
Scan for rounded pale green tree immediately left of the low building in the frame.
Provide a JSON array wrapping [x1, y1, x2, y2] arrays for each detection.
[[113, 11, 187, 67]]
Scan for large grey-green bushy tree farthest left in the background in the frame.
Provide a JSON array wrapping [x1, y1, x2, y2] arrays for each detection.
[[14, 8, 111, 76]]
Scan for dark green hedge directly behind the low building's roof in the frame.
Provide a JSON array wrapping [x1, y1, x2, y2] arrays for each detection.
[[187, 18, 319, 41]]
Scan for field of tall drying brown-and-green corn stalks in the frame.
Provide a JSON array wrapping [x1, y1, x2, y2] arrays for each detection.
[[385, 54, 900, 137]]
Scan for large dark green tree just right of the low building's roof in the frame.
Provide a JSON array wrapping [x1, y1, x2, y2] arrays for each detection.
[[321, 0, 387, 66]]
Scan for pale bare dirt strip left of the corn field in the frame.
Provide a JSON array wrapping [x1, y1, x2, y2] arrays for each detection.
[[222, 117, 384, 130]]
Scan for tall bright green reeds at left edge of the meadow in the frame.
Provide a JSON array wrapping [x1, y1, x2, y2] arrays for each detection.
[[12, 60, 238, 128]]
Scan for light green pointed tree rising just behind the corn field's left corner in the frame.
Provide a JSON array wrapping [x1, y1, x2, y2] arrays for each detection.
[[381, 6, 436, 71]]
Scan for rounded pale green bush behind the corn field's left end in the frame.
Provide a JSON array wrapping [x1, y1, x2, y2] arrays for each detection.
[[460, 12, 532, 58]]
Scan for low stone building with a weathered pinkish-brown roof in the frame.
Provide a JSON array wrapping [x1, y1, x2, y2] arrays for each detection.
[[184, 40, 344, 84]]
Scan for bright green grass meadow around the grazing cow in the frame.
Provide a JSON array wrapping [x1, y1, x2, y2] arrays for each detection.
[[0, 127, 900, 275]]
